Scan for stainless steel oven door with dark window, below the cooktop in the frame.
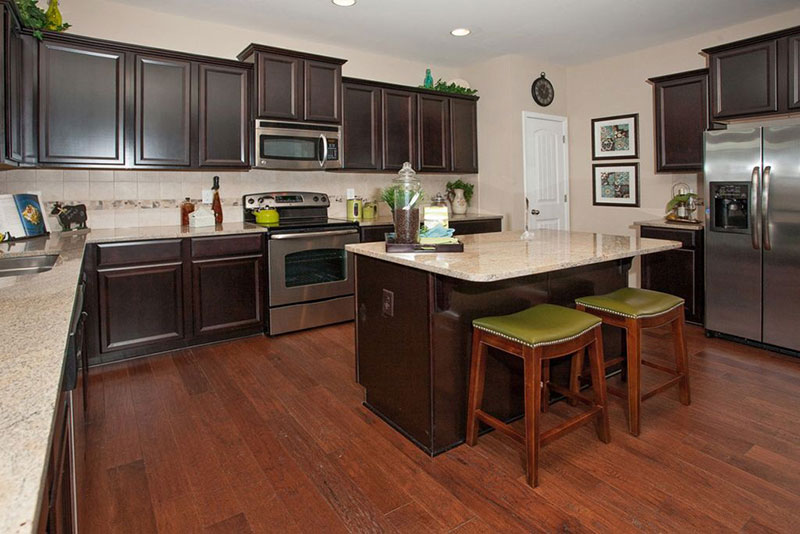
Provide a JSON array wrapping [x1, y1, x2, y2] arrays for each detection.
[[268, 228, 359, 306]]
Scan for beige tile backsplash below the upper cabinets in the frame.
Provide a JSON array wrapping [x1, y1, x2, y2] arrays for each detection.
[[0, 169, 478, 230]]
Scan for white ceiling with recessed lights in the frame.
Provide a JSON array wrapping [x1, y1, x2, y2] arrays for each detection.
[[116, 0, 798, 67]]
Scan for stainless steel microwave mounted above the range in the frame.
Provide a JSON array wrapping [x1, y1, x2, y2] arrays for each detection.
[[255, 120, 342, 170]]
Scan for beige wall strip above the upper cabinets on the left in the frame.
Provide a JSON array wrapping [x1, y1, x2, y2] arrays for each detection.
[[61, 0, 457, 85]]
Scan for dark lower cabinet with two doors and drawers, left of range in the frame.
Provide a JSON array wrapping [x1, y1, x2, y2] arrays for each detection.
[[85, 233, 265, 363]]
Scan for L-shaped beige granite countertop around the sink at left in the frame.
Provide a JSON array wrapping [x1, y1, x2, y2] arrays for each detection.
[[0, 222, 265, 533]]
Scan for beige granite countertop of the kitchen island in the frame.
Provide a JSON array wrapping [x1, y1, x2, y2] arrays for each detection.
[[346, 230, 681, 282]]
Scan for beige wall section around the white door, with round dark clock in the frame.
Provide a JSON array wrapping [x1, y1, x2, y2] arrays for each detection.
[[461, 55, 568, 229]]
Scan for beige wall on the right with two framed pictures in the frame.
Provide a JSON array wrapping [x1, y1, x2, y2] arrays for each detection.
[[567, 9, 800, 234]]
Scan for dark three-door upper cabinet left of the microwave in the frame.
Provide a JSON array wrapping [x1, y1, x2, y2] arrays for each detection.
[[38, 33, 252, 169]]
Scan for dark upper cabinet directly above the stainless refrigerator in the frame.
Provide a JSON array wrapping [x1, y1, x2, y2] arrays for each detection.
[[703, 27, 800, 119]]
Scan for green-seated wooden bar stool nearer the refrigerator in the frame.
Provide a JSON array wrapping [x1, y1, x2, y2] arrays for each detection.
[[575, 287, 691, 436]]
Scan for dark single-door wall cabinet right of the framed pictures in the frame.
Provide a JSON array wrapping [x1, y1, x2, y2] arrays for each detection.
[[655, 74, 708, 172]]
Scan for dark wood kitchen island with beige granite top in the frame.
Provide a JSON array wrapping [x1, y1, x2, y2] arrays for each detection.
[[346, 230, 680, 455]]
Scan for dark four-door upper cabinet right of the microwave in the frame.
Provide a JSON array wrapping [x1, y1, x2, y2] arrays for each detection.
[[342, 78, 478, 174]]
